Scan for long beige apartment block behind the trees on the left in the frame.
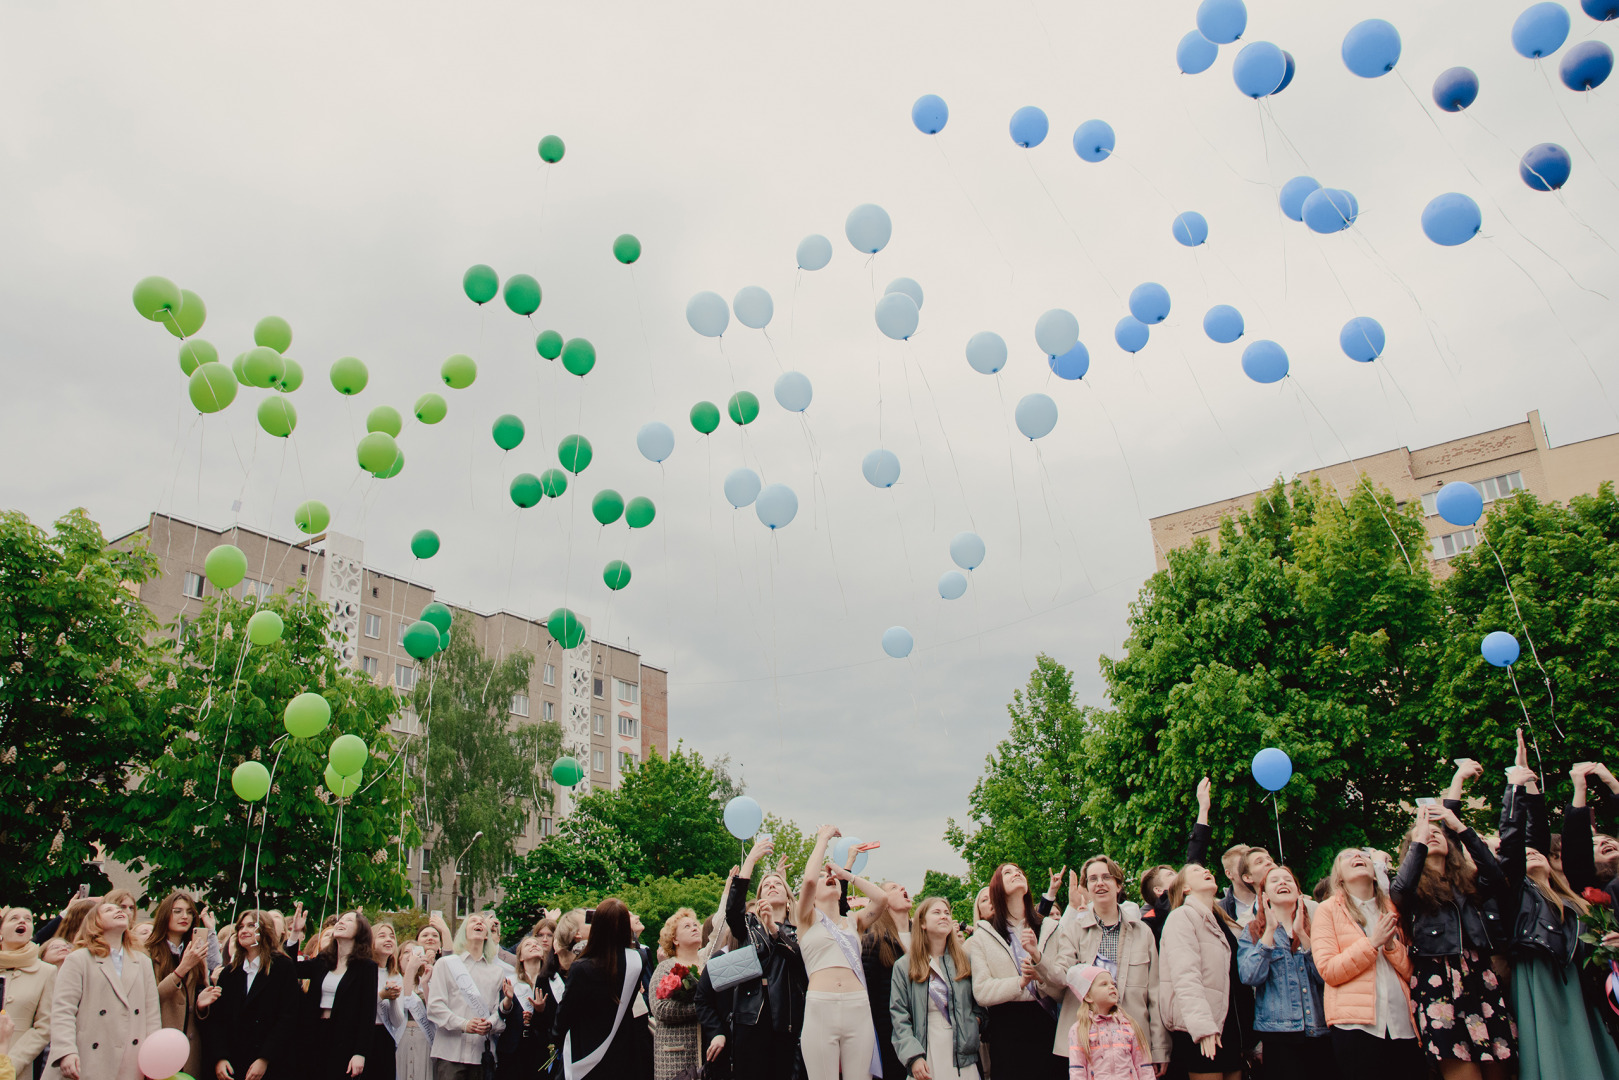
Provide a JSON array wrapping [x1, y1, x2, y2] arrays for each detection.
[[113, 513, 669, 910]]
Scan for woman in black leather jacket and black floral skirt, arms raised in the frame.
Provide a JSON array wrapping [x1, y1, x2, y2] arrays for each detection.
[[1389, 806, 1517, 1080]]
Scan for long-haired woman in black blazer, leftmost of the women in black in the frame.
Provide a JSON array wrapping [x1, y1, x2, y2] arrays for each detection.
[[198, 912, 300, 1080]]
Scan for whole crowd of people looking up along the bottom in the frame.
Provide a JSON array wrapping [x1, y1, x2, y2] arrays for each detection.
[[9, 748, 1619, 1080]]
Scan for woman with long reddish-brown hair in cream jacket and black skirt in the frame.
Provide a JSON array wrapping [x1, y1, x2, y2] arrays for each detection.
[[967, 863, 1067, 1080]]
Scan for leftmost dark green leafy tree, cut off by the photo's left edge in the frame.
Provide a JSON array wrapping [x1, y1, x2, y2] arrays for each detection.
[[0, 510, 160, 908]]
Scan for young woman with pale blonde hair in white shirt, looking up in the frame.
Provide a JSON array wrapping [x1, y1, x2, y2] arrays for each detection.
[[427, 913, 507, 1080]]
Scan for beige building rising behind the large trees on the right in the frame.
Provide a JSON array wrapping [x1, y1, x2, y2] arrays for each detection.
[[1151, 411, 1619, 573]]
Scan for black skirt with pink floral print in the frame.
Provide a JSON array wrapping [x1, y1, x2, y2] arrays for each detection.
[[1412, 949, 1517, 1062]]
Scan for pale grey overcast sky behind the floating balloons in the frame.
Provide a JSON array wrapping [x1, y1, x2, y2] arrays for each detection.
[[0, 0, 1619, 884]]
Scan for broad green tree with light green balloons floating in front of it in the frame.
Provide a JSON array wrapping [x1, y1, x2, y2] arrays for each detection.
[[115, 589, 419, 912]]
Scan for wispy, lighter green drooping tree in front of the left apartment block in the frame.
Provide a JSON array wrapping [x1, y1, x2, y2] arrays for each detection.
[[413, 612, 562, 894]]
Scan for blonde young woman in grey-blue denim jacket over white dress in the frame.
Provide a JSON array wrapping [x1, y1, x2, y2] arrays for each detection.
[[882, 897, 979, 1080]]
